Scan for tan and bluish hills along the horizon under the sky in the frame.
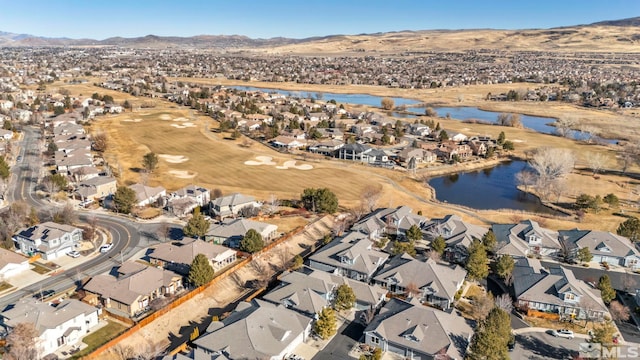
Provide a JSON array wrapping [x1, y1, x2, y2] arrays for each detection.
[[0, 17, 640, 55]]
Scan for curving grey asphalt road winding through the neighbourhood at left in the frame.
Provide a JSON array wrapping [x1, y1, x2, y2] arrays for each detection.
[[0, 127, 145, 311]]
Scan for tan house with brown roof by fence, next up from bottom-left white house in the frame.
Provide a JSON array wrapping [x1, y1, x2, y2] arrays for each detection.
[[83, 262, 182, 317]]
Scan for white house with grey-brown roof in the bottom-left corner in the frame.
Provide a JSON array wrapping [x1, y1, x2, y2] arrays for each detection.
[[0, 298, 101, 358]]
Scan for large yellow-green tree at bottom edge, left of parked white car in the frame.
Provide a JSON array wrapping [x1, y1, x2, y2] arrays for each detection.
[[466, 307, 511, 360]]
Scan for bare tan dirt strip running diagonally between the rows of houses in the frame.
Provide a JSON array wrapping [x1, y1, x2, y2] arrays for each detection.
[[100, 215, 334, 360]]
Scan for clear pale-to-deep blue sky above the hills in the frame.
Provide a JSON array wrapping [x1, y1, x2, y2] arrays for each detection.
[[0, 0, 640, 40]]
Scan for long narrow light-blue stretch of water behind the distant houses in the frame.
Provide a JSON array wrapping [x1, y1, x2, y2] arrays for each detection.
[[231, 86, 618, 144]]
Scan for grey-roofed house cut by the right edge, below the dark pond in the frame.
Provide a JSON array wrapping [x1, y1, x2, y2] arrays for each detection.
[[558, 229, 640, 270]]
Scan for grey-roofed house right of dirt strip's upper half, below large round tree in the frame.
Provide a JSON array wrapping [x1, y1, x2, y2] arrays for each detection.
[[309, 231, 389, 282]]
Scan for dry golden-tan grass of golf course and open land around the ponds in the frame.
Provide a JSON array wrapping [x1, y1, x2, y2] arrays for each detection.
[[48, 79, 638, 230]]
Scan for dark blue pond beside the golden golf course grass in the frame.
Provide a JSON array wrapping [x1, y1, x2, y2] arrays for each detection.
[[428, 160, 557, 214]]
